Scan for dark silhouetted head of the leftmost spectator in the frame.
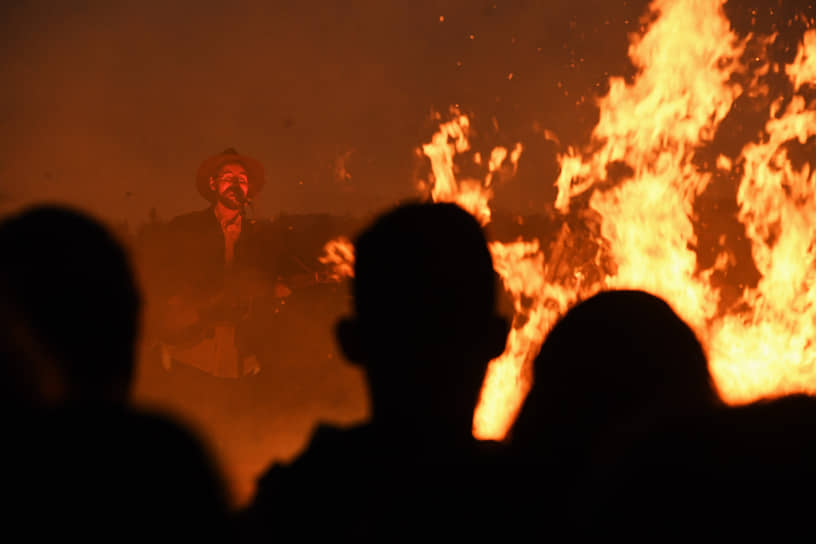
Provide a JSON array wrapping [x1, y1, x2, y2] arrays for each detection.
[[0, 206, 140, 400]]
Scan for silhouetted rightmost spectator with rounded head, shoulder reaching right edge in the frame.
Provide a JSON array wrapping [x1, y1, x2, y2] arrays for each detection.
[[505, 291, 816, 541]]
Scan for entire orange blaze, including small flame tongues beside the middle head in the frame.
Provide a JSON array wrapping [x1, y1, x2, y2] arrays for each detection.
[[328, 0, 816, 438]]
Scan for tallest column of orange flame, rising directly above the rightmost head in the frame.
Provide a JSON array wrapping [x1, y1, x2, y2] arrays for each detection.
[[556, 0, 743, 328]]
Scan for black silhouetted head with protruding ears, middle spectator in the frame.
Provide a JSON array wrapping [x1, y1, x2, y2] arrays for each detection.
[[337, 204, 507, 433]]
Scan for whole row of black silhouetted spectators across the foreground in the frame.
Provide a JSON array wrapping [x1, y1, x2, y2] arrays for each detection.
[[0, 203, 816, 542]]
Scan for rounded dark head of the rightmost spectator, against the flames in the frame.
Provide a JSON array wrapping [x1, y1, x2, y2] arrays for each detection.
[[512, 291, 718, 456]]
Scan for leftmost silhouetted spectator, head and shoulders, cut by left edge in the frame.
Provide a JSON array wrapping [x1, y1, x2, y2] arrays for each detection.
[[0, 206, 227, 541]]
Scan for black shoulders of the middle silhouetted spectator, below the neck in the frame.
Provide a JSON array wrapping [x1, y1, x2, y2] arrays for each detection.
[[240, 424, 505, 541]]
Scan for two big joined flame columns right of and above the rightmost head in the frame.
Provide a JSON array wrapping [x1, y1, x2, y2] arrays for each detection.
[[556, 0, 816, 403]]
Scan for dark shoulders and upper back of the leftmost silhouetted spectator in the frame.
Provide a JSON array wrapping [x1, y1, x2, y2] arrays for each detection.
[[23, 405, 233, 541]]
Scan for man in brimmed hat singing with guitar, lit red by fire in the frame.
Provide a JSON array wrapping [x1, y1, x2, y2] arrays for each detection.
[[153, 148, 288, 378]]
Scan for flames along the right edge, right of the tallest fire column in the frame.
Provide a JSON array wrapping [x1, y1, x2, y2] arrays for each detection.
[[710, 30, 816, 402]]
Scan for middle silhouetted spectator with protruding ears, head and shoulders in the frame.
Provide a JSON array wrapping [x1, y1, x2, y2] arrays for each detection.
[[242, 204, 507, 540]]
